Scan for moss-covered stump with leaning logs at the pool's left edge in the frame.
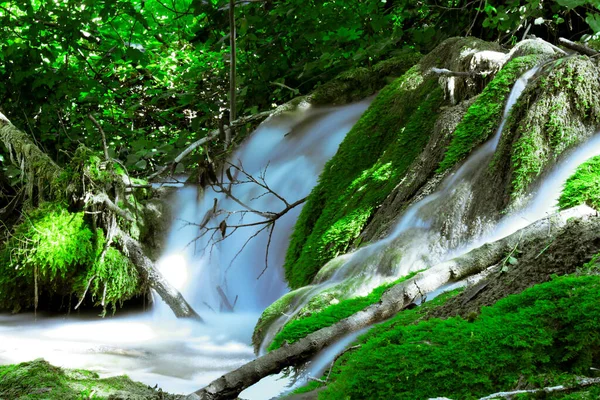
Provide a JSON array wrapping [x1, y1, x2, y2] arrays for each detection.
[[0, 114, 200, 319]]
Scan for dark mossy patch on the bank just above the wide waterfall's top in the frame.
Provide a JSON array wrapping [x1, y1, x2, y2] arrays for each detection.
[[310, 50, 421, 105]]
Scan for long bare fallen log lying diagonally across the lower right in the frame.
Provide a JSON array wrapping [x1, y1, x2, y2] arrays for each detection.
[[188, 206, 595, 400]]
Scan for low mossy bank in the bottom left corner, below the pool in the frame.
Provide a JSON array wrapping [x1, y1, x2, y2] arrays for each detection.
[[0, 359, 175, 400]]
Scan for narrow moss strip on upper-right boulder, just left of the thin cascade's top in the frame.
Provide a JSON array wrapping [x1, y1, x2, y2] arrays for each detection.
[[438, 55, 542, 172]]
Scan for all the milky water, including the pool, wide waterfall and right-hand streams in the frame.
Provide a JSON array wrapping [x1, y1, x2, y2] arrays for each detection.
[[0, 69, 600, 399]]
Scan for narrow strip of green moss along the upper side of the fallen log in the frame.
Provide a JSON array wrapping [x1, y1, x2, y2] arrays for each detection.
[[269, 272, 416, 351]]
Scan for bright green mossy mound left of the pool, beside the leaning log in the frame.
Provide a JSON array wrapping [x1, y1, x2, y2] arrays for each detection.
[[0, 203, 144, 311]]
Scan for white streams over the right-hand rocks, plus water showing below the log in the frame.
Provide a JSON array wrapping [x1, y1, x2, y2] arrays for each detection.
[[253, 63, 600, 393]]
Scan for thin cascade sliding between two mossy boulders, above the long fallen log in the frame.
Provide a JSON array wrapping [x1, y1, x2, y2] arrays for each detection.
[[261, 67, 538, 353]]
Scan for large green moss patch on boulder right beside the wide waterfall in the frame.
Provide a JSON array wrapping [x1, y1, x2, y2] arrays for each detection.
[[285, 66, 444, 288]]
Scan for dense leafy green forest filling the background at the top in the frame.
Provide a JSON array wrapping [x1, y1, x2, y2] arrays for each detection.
[[0, 0, 600, 185]]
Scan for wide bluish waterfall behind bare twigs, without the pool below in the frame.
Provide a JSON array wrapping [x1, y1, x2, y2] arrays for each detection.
[[158, 100, 370, 315]]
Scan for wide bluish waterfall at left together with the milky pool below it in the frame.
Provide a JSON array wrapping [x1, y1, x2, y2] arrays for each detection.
[[0, 100, 370, 399]]
